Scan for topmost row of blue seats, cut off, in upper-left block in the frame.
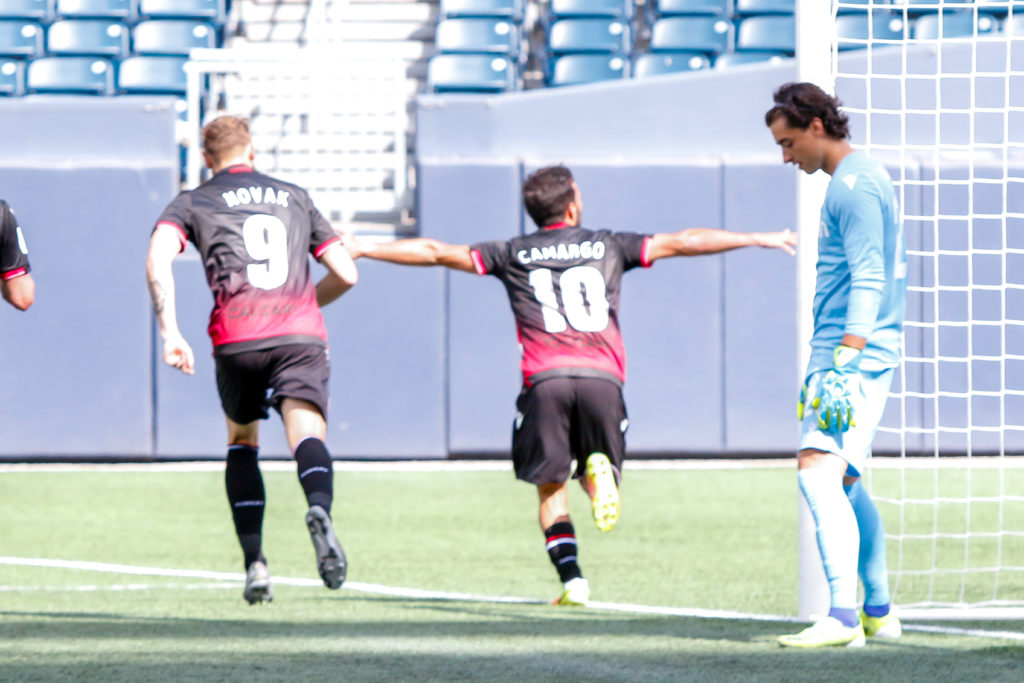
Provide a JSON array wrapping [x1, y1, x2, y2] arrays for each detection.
[[0, 0, 224, 24]]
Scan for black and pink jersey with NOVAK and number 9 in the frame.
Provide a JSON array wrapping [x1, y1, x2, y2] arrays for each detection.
[[157, 165, 339, 353]]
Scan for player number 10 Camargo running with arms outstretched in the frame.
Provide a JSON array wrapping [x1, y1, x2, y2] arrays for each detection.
[[349, 166, 796, 605]]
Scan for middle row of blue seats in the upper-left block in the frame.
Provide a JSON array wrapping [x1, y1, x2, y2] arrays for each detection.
[[0, 19, 217, 57]]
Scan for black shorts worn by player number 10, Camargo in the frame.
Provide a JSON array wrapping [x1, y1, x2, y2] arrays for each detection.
[[512, 377, 629, 485]]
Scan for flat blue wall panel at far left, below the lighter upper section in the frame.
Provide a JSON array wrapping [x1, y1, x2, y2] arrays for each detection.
[[0, 168, 170, 457]]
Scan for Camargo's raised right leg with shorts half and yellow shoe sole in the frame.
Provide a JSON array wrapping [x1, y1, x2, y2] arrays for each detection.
[[571, 378, 629, 531]]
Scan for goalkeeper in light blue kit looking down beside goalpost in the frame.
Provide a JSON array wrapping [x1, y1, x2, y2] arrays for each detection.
[[765, 83, 906, 647]]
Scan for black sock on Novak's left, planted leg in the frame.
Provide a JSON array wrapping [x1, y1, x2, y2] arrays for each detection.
[[224, 443, 266, 569]]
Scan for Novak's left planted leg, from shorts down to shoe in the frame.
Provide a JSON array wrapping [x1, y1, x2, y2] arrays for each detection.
[[215, 353, 273, 604]]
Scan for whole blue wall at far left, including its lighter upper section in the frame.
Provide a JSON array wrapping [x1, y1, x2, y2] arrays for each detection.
[[0, 97, 177, 458]]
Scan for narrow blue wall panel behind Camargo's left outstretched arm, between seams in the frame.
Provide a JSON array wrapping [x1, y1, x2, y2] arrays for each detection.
[[415, 159, 522, 454]]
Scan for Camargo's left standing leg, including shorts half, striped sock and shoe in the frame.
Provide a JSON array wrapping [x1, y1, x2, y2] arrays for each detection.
[[512, 378, 590, 605]]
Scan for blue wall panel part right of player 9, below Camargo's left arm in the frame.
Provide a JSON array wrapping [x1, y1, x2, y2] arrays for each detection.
[[317, 259, 446, 458]]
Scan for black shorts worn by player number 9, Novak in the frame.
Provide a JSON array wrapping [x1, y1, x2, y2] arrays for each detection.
[[214, 344, 331, 425]]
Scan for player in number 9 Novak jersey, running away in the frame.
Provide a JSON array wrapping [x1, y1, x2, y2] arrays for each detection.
[[146, 116, 357, 604]]
